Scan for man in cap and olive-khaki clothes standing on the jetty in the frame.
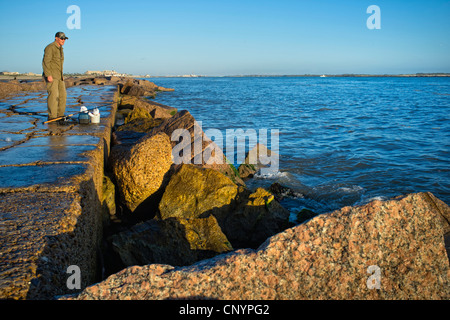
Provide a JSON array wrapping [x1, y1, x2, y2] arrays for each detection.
[[42, 32, 69, 120]]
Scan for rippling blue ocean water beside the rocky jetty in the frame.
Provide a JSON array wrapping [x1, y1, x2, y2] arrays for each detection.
[[148, 77, 450, 213]]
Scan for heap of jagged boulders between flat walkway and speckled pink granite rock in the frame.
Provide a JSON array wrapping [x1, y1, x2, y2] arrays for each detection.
[[103, 91, 290, 269]]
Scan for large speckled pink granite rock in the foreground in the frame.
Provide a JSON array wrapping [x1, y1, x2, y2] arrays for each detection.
[[63, 193, 450, 299]]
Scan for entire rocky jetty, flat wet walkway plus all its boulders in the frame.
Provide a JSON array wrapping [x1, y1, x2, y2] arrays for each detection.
[[0, 77, 450, 300]]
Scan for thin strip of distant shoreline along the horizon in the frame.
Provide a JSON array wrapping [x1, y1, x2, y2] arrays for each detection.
[[0, 73, 450, 81]]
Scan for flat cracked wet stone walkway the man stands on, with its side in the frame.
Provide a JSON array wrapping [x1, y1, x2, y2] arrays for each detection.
[[0, 85, 117, 299]]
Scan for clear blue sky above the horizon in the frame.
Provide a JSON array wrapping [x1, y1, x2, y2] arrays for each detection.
[[0, 0, 450, 75]]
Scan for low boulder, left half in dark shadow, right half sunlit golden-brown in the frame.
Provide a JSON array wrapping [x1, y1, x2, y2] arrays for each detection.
[[105, 216, 233, 267]]
